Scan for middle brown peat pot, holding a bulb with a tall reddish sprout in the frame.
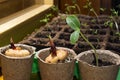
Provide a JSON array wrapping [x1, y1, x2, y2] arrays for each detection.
[[37, 47, 76, 80]]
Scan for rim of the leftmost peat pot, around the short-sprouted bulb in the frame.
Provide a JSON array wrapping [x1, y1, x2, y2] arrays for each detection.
[[0, 44, 36, 59]]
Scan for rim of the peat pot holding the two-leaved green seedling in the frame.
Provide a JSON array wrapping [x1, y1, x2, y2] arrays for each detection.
[[75, 49, 120, 68]]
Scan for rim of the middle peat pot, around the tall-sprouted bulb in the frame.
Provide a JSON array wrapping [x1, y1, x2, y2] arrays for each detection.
[[35, 47, 77, 65]]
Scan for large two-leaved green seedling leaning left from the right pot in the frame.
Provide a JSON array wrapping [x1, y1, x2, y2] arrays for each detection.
[[66, 15, 98, 66]]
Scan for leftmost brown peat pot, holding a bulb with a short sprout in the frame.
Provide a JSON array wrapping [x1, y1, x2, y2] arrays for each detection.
[[0, 44, 35, 80]]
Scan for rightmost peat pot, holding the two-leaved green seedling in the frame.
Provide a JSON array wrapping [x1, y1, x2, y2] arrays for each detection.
[[76, 50, 120, 80]]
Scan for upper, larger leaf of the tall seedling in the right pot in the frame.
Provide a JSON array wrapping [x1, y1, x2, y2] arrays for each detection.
[[66, 15, 80, 30]]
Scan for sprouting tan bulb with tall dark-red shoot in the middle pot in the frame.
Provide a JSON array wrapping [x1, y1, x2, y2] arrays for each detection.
[[45, 36, 68, 63]]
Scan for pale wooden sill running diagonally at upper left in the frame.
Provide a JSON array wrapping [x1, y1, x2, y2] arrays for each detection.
[[0, 4, 52, 34]]
